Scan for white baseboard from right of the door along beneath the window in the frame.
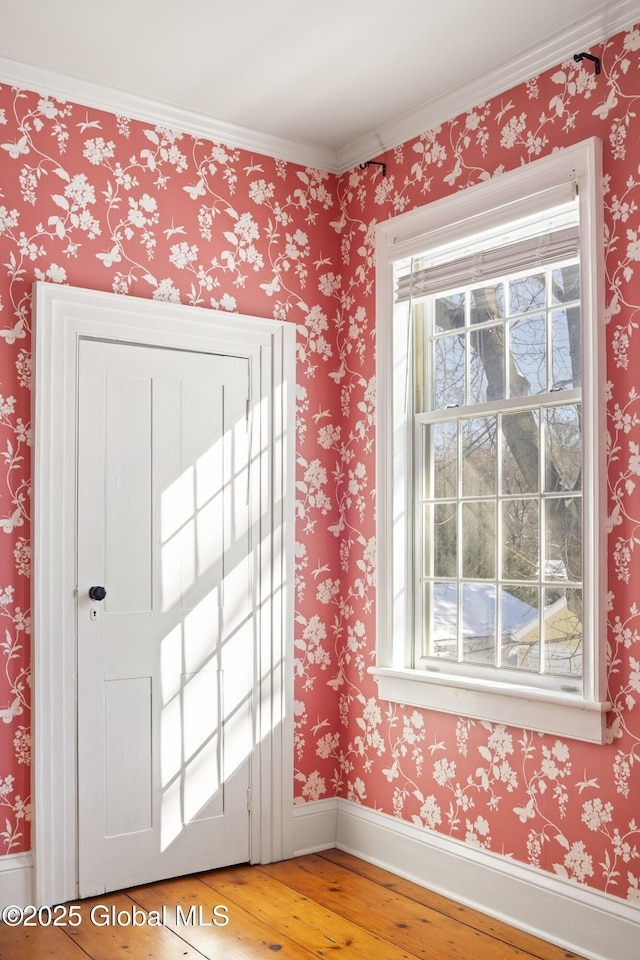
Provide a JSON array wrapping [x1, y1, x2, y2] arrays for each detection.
[[294, 800, 640, 960]]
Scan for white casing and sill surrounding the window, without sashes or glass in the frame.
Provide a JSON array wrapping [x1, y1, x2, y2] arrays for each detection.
[[370, 138, 611, 743]]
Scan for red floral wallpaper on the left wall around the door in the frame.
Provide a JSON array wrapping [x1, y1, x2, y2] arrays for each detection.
[[0, 88, 340, 853]]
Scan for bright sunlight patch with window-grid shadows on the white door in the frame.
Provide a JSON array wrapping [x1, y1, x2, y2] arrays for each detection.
[[159, 410, 256, 850]]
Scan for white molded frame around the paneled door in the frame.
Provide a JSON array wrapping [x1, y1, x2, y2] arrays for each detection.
[[32, 283, 295, 905]]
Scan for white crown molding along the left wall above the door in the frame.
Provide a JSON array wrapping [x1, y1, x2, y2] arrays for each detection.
[[0, 55, 340, 173]]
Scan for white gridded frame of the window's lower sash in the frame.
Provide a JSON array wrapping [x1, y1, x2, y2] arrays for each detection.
[[413, 402, 585, 693]]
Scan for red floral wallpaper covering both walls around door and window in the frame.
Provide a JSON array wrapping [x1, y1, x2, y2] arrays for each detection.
[[0, 20, 640, 903]]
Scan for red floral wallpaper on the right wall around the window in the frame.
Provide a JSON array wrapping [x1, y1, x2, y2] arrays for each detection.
[[299, 29, 640, 903]]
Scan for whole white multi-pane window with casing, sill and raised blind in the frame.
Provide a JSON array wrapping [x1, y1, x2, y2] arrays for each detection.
[[372, 140, 608, 742]]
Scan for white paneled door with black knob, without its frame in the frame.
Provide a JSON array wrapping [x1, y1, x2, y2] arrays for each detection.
[[77, 339, 255, 897]]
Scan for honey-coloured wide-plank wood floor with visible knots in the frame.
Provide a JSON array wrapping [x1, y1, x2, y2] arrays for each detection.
[[0, 850, 580, 960]]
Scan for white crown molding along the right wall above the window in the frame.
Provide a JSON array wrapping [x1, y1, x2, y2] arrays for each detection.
[[337, 0, 640, 173]]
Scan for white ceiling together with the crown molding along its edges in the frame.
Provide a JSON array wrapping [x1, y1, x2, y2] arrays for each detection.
[[0, 0, 640, 172]]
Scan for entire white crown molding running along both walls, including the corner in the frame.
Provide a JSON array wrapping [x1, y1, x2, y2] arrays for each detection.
[[0, 0, 640, 174]]
